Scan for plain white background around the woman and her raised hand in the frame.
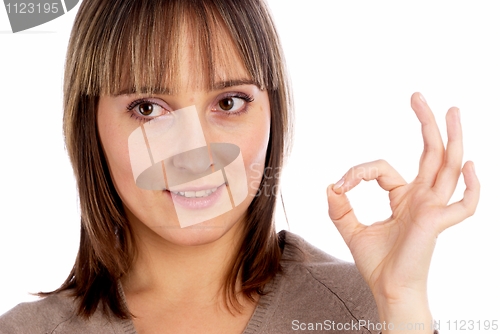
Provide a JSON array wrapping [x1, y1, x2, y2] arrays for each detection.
[[0, 0, 500, 333]]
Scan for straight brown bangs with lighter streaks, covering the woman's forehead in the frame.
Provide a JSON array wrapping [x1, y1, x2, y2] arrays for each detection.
[[74, 0, 280, 96]]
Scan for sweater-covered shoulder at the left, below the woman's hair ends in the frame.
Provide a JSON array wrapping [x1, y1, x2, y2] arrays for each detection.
[[0, 291, 133, 334]]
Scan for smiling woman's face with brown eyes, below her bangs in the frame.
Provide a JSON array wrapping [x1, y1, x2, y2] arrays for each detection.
[[97, 41, 270, 245]]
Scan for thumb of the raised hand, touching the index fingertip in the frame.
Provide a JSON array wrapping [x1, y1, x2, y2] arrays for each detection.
[[327, 178, 363, 245]]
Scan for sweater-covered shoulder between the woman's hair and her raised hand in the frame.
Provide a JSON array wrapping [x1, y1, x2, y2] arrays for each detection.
[[252, 232, 379, 333]]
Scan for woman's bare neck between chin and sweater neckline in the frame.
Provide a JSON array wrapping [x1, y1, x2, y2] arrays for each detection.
[[122, 215, 243, 307]]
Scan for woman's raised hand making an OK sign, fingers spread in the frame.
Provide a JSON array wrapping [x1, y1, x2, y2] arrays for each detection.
[[328, 93, 479, 332]]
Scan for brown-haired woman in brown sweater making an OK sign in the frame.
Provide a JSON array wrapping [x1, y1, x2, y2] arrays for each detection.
[[0, 1, 479, 333]]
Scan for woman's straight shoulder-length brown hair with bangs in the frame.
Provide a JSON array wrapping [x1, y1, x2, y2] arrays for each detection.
[[41, 0, 291, 318]]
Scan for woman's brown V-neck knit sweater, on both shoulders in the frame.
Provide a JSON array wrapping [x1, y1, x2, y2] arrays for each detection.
[[0, 232, 404, 334]]
